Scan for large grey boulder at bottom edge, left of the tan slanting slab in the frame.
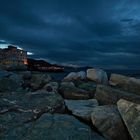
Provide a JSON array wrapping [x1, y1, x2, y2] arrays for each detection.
[[91, 106, 129, 140]]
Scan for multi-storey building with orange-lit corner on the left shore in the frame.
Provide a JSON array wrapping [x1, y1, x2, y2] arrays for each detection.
[[0, 45, 27, 65]]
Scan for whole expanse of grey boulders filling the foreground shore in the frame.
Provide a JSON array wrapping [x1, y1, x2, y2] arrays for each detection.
[[0, 69, 140, 140]]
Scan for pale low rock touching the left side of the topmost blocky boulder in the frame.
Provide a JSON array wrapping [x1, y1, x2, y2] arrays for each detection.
[[63, 71, 86, 82]]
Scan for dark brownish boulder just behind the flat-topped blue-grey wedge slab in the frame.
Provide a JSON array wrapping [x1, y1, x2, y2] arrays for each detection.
[[59, 82, 90, 100]]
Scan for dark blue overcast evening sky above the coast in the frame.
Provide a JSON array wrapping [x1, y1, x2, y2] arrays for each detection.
[[0, 0, 140, 69]]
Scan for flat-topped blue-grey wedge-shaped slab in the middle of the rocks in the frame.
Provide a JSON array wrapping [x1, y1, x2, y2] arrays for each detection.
[[65, 99, 98, 121]]
